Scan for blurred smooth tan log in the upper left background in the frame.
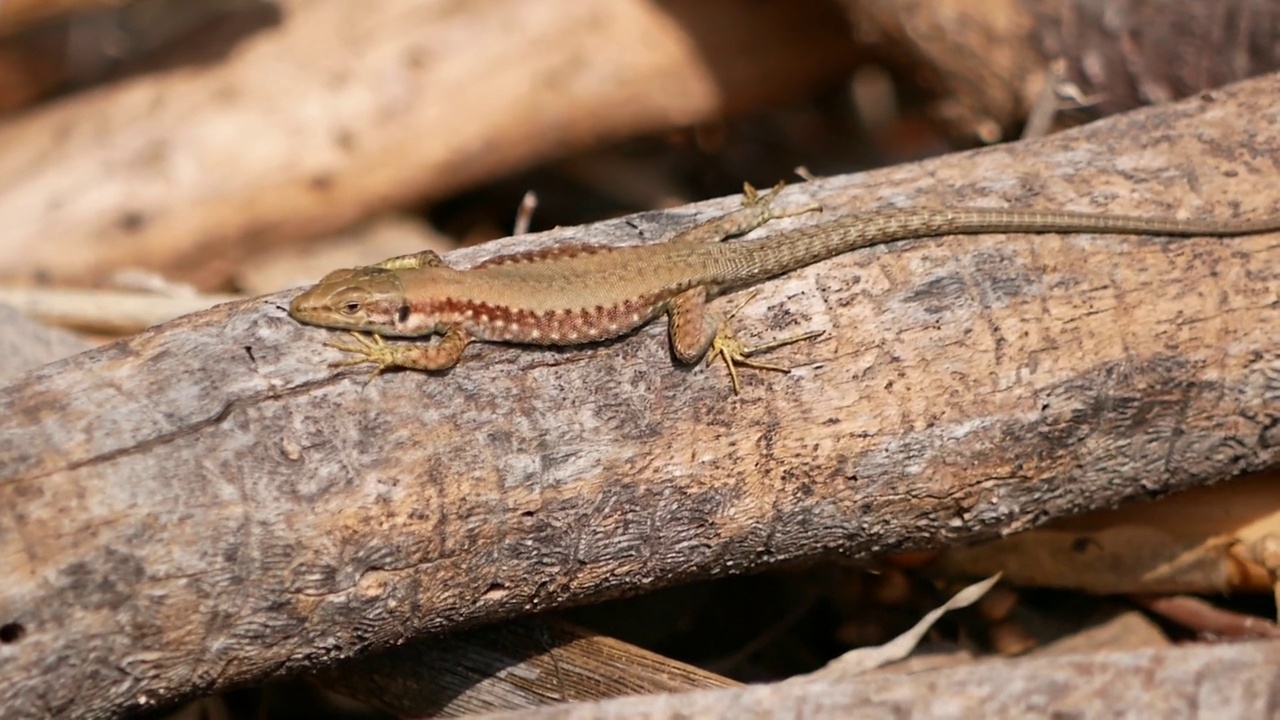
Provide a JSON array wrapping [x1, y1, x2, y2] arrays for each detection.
[[0, 0, 852, 288]]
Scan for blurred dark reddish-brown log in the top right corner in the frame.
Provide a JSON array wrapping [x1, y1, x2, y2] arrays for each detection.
[[842, 0, 1280, 142]]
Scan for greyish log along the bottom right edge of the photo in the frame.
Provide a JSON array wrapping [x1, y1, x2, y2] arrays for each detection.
[[484, 642, 1280, 720]]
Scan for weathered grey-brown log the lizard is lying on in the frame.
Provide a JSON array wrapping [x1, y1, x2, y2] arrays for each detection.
[[0, 77, 1280, 716]]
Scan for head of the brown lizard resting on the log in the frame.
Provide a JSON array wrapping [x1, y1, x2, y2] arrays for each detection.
[[289, 268, 412, 336]]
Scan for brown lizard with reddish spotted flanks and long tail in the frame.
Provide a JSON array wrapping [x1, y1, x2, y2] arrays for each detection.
[[289, 186, 1280, 392]]
